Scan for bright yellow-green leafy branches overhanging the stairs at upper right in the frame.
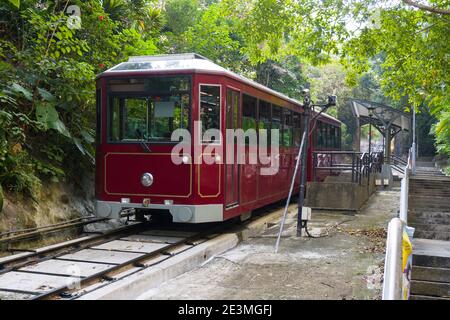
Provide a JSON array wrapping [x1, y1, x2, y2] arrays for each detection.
[[343, 0, 450, 159]]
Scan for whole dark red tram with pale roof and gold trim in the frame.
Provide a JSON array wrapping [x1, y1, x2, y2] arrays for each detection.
[[95, 54, 340, 223]]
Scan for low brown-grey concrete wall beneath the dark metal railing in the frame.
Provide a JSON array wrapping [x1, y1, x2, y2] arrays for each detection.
[[306, 175, 375, 211]]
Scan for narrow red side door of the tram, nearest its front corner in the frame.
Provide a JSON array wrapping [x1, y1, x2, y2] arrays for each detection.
[[225, 89, 240, 207]]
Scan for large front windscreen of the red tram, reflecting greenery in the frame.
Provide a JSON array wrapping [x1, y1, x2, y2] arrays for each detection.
[[108, 77, 190, 142]]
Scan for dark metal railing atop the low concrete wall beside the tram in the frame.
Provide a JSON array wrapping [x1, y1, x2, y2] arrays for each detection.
[[313, 151, 383, 184]]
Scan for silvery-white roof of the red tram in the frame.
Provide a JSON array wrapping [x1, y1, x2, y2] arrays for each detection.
[[99, 53, 341, 123]]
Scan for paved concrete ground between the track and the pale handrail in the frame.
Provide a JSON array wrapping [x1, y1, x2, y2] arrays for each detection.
[[140, 189, 399, 299]]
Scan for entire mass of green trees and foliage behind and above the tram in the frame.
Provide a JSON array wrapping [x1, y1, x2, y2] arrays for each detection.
[[0, 0, 450, 199]]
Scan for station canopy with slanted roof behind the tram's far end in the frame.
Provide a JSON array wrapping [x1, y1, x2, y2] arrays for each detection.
[[351, 99, 411, 136]]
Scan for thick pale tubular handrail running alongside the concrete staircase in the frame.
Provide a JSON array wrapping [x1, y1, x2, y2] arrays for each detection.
[[382, 149, 412, 300]]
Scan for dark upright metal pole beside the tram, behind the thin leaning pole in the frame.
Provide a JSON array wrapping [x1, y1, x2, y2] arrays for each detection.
[[297, 92, 311, 237]]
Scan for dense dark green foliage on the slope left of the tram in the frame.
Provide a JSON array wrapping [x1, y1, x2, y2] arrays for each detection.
[[0, 0, 162, 195]]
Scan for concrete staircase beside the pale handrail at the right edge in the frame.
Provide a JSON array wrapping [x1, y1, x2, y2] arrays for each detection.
[[408, 171, 450, 300]]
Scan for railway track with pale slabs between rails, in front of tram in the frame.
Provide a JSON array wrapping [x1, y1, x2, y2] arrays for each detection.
[[0, 205, 288, 300]]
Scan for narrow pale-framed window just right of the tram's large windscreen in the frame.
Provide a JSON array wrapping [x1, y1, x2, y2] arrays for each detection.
[[200, 85, 220, 142]]
